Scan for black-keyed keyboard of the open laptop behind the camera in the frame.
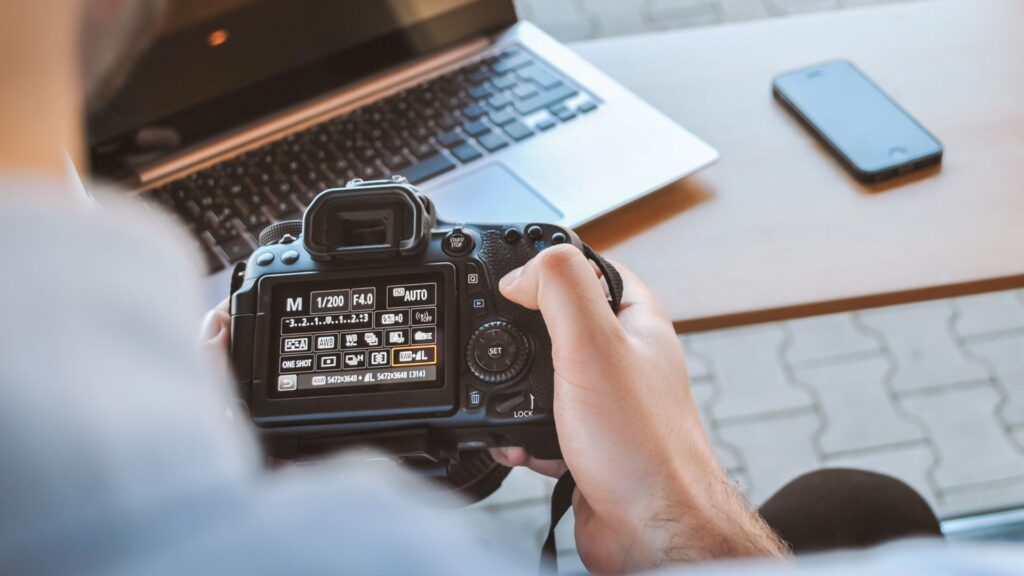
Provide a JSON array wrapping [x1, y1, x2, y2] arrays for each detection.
[[151, 47, 598, 273]]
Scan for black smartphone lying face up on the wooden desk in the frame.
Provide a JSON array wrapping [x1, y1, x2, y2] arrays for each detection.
[[772, 60, 942, 182]]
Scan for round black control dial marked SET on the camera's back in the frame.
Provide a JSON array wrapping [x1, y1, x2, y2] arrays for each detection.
[[466, 320, 529, 384]]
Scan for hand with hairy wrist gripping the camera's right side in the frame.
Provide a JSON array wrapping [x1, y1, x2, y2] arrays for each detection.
[[492, 245, 786, 573]]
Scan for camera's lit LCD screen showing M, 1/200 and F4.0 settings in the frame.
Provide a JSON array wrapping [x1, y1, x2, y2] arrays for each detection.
[[267, 272, 445, 398]]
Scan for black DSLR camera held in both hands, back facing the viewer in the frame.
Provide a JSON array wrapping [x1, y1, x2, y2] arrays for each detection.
[[230, 177, 583, 463]]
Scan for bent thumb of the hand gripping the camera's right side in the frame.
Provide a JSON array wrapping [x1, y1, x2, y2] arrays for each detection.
[[499, 244, 625, 354]]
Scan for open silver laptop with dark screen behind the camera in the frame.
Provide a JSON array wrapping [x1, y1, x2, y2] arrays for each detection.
[[88, 0, 717, 293]]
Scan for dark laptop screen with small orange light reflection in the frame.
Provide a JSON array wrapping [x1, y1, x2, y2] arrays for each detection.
[[88, 0, 515, 179]]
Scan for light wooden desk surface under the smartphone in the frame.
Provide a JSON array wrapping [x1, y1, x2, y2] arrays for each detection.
[[574, 0, 1024, 331]]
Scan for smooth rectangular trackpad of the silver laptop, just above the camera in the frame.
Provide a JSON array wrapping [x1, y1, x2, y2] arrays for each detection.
[[427, 163, 562, 223]]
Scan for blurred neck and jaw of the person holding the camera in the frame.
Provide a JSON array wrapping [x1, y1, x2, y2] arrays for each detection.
[[0, 0, 167, 173]]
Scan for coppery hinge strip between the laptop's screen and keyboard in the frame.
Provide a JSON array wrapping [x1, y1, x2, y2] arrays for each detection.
[[134, 38, 494, 190]]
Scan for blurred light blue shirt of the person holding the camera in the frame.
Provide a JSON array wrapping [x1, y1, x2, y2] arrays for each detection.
[[0, 180, 1024, 576]]
